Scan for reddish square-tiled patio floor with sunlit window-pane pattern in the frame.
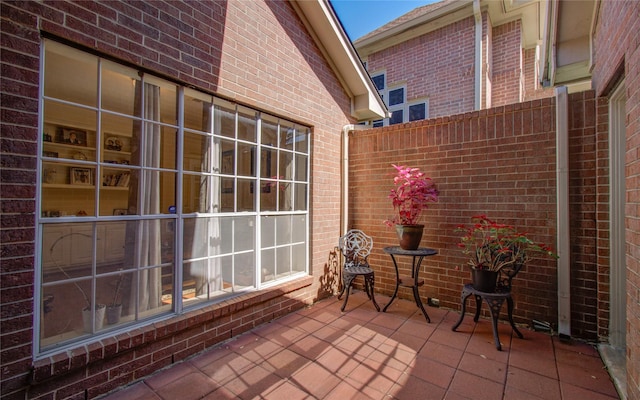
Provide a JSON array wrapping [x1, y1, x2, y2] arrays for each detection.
[[104, 292, 619, 400]]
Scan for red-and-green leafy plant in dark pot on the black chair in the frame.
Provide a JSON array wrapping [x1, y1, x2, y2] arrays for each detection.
[[456, 215, 557, 292]]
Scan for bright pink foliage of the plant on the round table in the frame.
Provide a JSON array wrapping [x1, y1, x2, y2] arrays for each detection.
[[384, 164, 439, 226]]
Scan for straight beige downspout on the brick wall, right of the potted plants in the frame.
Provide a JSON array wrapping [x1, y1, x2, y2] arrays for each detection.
[[555, 86, 571, 339]]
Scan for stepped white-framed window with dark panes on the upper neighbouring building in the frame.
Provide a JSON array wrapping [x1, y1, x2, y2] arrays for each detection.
[[371, 72, 429, 128]]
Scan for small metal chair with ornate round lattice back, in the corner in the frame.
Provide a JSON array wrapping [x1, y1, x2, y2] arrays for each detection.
[[338, 229, 380, 311]]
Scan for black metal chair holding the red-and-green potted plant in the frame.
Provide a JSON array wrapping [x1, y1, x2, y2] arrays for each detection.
[[451, 263, 524, 350]]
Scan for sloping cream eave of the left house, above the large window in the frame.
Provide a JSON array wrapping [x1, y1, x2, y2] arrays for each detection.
[[290, 0, 389, 121]]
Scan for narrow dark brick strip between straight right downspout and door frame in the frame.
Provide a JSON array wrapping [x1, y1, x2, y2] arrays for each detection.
[[569, 91, 609, 340]]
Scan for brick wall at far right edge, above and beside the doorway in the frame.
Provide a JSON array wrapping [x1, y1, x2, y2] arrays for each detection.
[[593, 1, 640, 399]]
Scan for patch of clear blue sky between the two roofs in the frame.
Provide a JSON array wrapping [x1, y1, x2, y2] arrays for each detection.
[[330, 0, 438, 42]]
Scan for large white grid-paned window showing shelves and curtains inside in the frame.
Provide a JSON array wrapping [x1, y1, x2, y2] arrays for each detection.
[[35, 40, 310, 354]]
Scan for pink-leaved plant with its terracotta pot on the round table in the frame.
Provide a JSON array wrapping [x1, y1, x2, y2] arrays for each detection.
[[385, 164, 438, 250]]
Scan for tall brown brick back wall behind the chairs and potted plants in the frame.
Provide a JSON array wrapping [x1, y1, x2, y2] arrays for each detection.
[[349, 92, 608, 340]]
